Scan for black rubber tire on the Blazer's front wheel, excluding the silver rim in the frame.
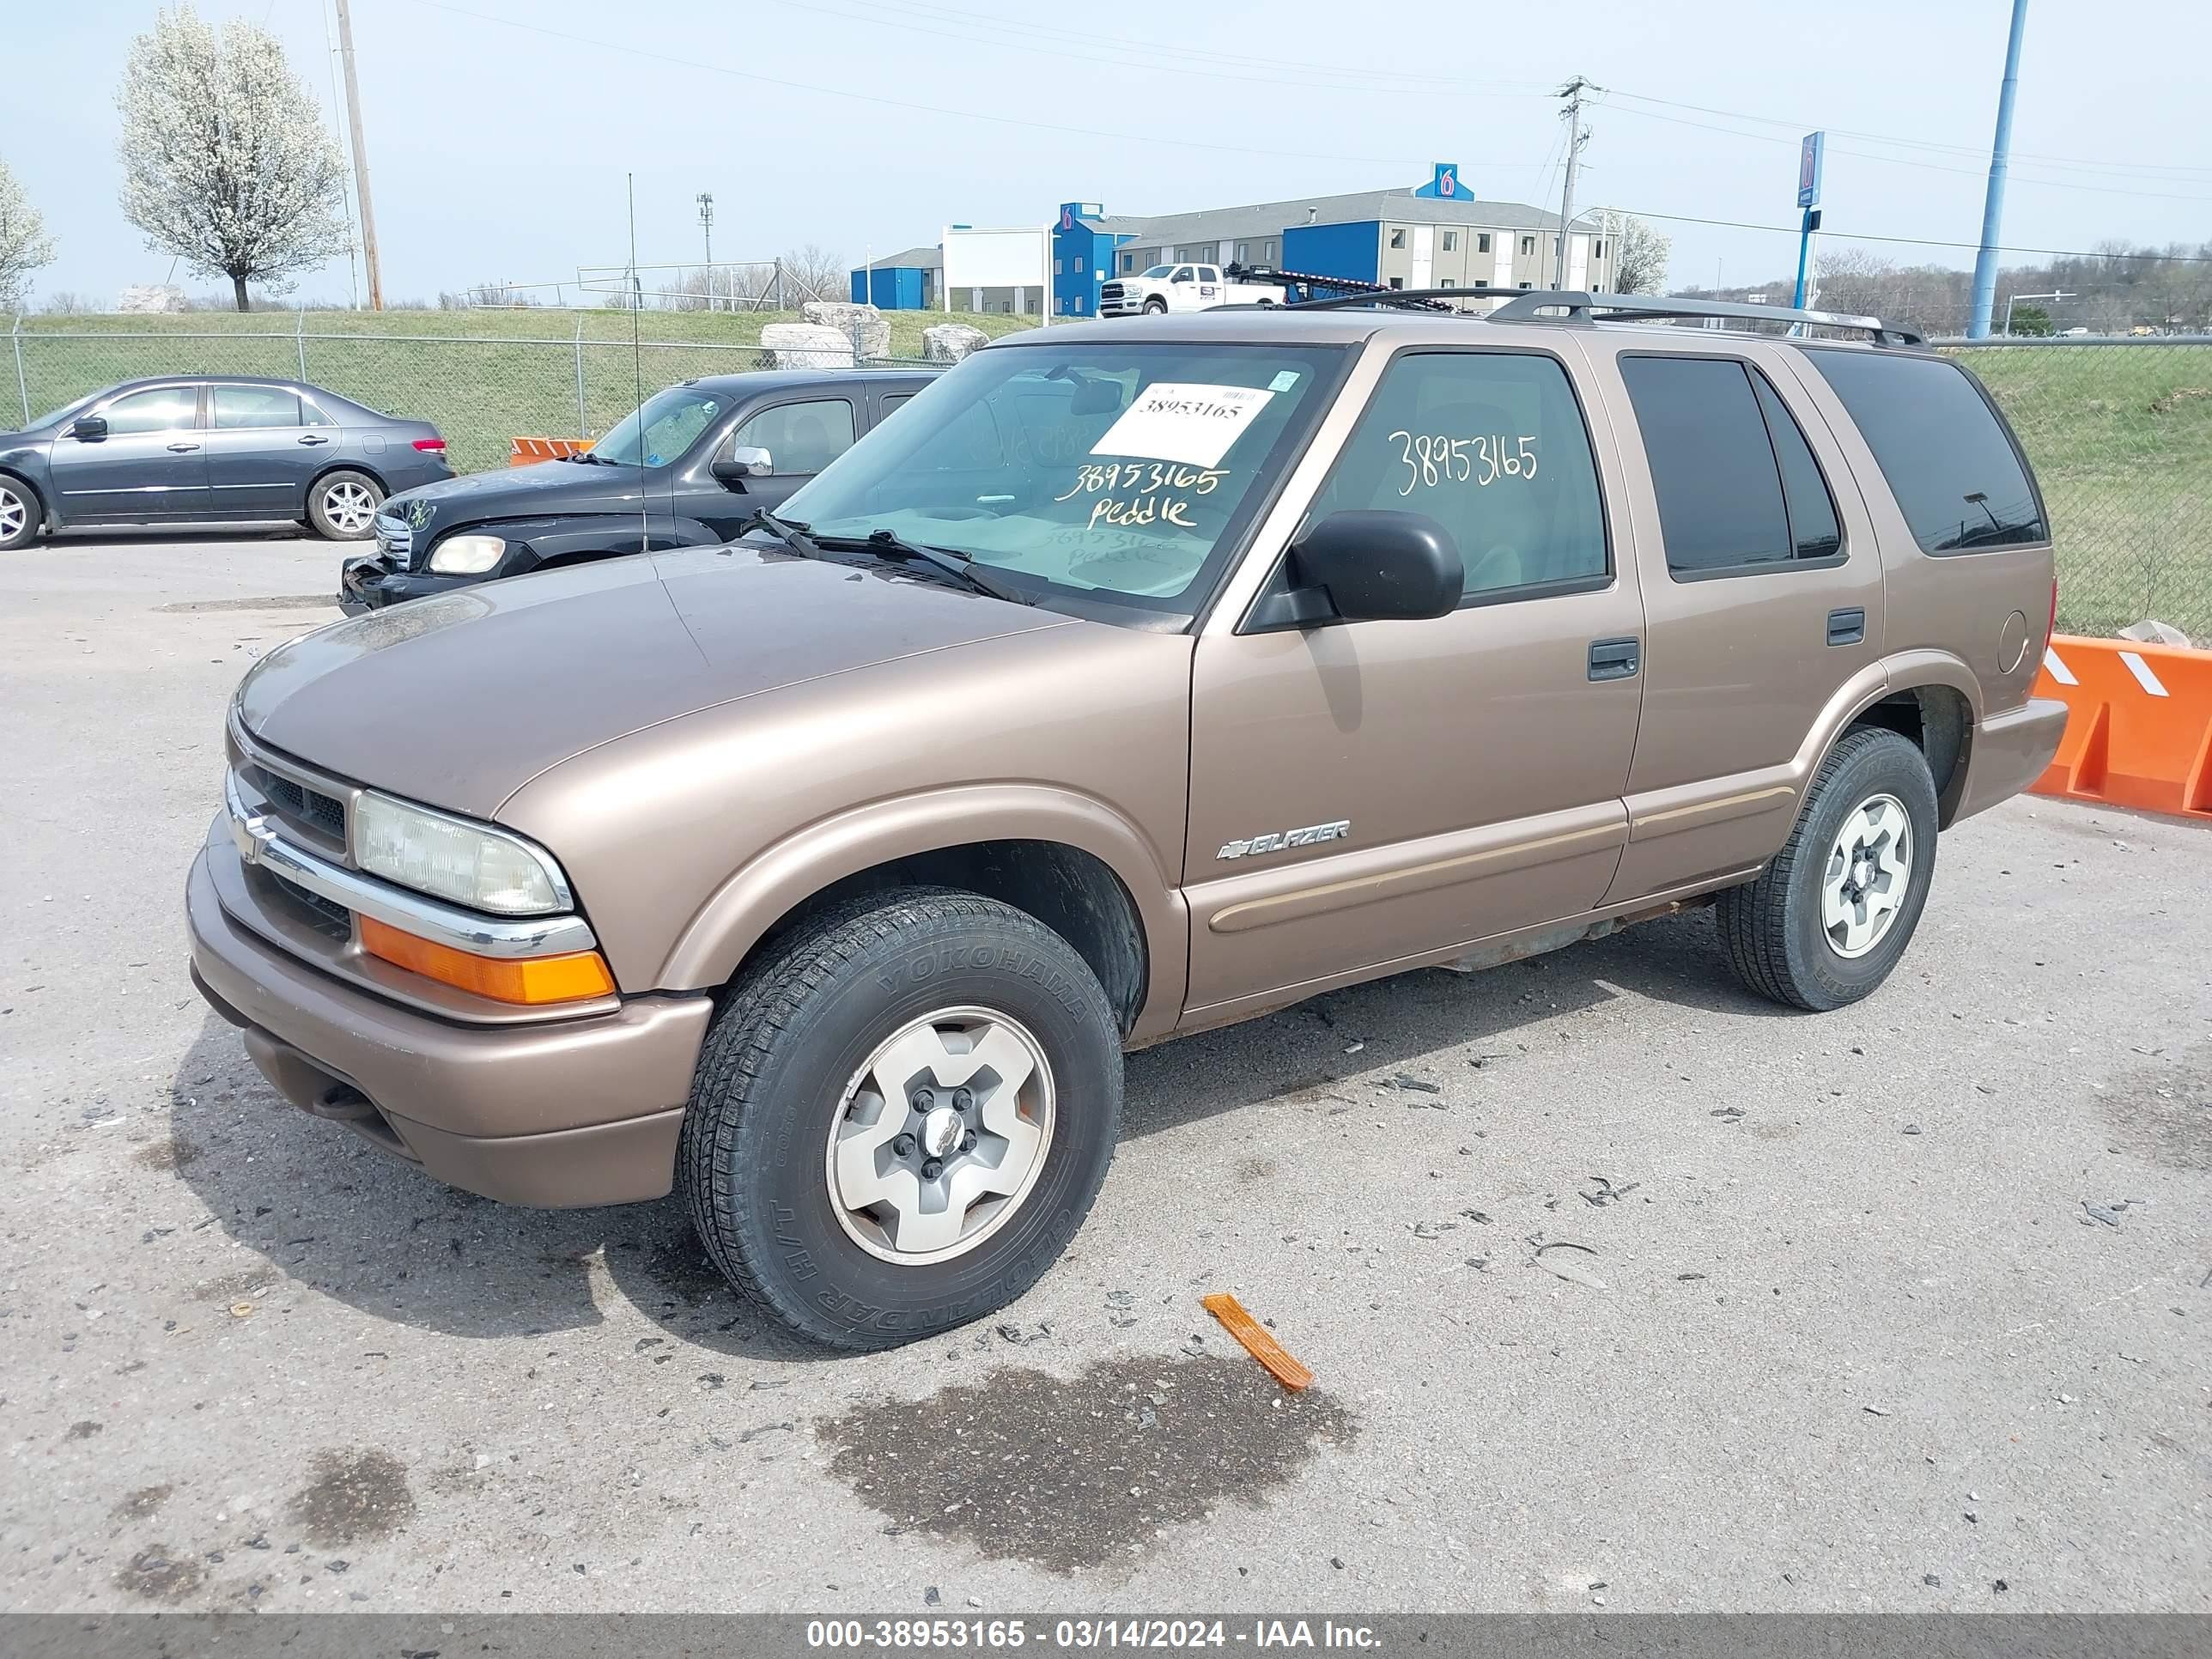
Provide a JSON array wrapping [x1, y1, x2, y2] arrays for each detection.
[[677, 887, 1121, 1349]]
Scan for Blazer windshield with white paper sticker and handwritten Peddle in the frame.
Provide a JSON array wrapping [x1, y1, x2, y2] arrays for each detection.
[[785, 343, 1343, 615]]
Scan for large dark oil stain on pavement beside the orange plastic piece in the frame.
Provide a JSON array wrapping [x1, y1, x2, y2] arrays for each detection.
[[818, 1356, 1354, 1573]]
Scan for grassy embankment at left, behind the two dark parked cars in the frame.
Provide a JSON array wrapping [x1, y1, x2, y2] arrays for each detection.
[[15, 307, 1029, 471]]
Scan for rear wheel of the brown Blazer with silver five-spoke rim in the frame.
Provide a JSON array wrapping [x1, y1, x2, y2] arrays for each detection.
[[1717, 726, 1936, 1013]]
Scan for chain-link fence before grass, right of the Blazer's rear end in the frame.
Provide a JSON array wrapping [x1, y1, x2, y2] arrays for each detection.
[[1940, 337, 2212, 646]]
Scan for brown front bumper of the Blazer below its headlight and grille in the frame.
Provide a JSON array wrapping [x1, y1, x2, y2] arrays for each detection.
[[185, 836, 712, 1210]]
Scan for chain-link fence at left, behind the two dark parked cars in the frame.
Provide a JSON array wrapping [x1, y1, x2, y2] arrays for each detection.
[[0, 314, 942, 471]]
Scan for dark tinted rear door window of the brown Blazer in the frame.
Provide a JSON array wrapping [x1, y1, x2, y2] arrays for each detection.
[[1621, 356, 1843, 577]]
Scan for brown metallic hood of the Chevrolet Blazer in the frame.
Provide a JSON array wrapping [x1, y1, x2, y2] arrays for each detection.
[[239, 546, 1071, 818]]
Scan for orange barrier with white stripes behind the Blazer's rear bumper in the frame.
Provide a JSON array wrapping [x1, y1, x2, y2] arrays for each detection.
[[2035, 633, 2212, 818]]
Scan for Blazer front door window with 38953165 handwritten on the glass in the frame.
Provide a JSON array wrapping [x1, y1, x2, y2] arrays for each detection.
[[1307, 352, 1610, 599]]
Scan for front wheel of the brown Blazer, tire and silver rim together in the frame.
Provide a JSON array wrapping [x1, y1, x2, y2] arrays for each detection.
[[677, 887, 1121, 1349]]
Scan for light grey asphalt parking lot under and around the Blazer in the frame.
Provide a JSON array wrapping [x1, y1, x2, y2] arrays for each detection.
[[0, 538, 2212, 1613]]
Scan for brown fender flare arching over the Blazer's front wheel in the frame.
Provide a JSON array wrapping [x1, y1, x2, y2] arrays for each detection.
[[654, 783, 1190, 1037]]
